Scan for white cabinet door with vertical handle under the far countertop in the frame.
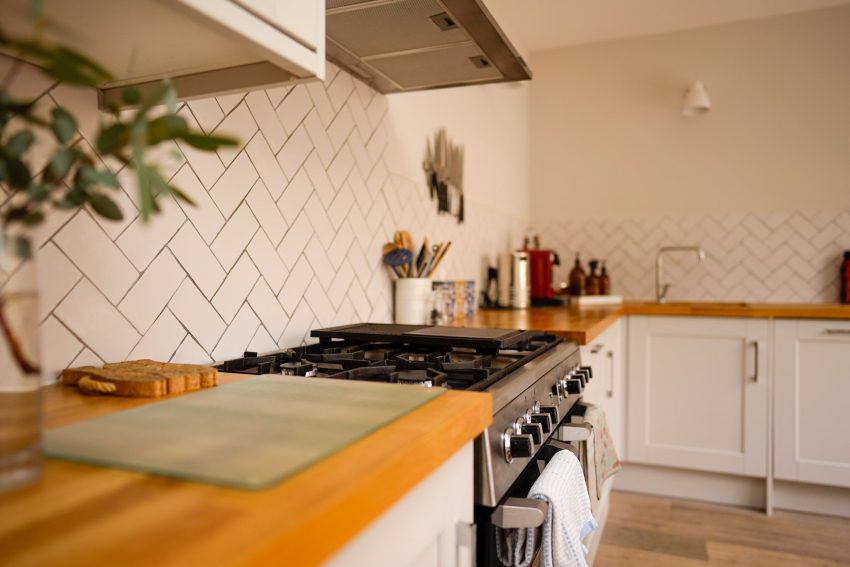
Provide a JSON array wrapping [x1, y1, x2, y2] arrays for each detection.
[[626, 316, 770, 477]]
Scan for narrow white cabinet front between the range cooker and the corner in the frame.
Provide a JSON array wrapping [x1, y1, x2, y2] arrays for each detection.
[[581, 319, 626, 459]]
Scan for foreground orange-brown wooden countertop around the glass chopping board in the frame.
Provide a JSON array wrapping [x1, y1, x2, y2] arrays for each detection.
[[0, 373, 492, 565]]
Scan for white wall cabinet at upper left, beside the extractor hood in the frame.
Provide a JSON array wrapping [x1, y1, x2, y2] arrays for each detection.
[[3, 0, 325, 105]]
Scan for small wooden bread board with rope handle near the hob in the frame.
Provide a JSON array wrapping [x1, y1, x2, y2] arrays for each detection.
[[62, 359, 218, 398]]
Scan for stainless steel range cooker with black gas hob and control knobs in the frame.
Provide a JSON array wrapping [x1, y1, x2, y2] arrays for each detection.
[[217, 323, 592, 565]]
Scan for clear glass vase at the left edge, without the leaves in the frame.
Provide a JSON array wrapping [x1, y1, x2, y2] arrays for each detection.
[[0, 237, 42, 492]]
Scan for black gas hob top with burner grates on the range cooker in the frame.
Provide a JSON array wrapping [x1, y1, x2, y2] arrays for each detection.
[[217, 323, 561, 390]]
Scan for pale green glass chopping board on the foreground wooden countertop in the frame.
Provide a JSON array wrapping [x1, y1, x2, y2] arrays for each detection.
[[45, 375, 445, 490]]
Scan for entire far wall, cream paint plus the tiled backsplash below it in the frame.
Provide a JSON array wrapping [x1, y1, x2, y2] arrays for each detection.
[[530, 6, 850, 302]]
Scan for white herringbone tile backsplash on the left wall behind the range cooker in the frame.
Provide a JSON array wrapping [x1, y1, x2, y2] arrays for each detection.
[[0, 60, 525, 379]]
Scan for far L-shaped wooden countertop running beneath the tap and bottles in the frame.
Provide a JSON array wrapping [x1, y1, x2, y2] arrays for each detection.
[[454, 301, 850, 345]]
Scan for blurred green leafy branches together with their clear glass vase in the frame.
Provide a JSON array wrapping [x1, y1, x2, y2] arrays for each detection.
[[0, 1, 235, 492]]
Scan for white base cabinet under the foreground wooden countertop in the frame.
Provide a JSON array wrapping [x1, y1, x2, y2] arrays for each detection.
[[324, 441, 475, 567]]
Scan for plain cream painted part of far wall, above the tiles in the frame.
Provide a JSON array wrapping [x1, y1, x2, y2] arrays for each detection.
[[530, 6, 850, 223]]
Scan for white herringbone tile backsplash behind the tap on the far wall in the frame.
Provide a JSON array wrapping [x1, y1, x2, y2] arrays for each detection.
[[540, 210, 850, 302]]
